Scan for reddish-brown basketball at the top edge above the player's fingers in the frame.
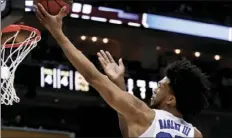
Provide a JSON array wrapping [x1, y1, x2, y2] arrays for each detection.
[[36, 0, 73, 15]]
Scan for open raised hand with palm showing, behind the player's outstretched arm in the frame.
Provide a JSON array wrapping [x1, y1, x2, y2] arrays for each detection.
[[97, 50, 125, 81]]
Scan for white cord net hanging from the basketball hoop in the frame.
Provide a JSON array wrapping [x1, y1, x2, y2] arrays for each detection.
[[0, 30, 41, 105]]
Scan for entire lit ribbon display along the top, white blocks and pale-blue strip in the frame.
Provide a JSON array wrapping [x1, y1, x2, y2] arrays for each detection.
[[25, 0, 232, 42]]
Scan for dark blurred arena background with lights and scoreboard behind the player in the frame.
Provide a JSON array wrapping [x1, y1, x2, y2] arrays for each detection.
[[1, 0, 232, 138]]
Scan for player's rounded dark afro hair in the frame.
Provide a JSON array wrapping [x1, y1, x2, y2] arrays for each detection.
[[165, 59, 210, 116]]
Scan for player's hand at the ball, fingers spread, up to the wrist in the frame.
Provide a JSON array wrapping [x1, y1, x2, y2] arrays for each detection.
[[34, 3, 67, 34]]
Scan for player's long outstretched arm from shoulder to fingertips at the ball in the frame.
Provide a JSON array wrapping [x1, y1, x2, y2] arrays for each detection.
[[36, 4, 154, 123]]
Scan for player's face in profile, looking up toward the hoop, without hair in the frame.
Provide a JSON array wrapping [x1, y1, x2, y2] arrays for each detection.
[[151, 77, 171, 109]]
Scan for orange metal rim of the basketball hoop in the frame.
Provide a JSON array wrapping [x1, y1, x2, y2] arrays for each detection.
[[2, 24, 41, 48]]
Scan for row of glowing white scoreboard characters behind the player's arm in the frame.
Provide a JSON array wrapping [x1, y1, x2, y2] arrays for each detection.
[[40, 67, 157, 99]]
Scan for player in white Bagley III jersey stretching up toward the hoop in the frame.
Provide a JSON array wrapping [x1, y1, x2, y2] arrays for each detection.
[[35, 4, 208, 138]]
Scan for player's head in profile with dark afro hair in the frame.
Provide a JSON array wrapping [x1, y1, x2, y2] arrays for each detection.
[[151, 60, 209, 116]]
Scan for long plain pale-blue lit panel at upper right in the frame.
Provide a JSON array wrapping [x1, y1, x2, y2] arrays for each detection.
[[146, 14, 230, 41]]
